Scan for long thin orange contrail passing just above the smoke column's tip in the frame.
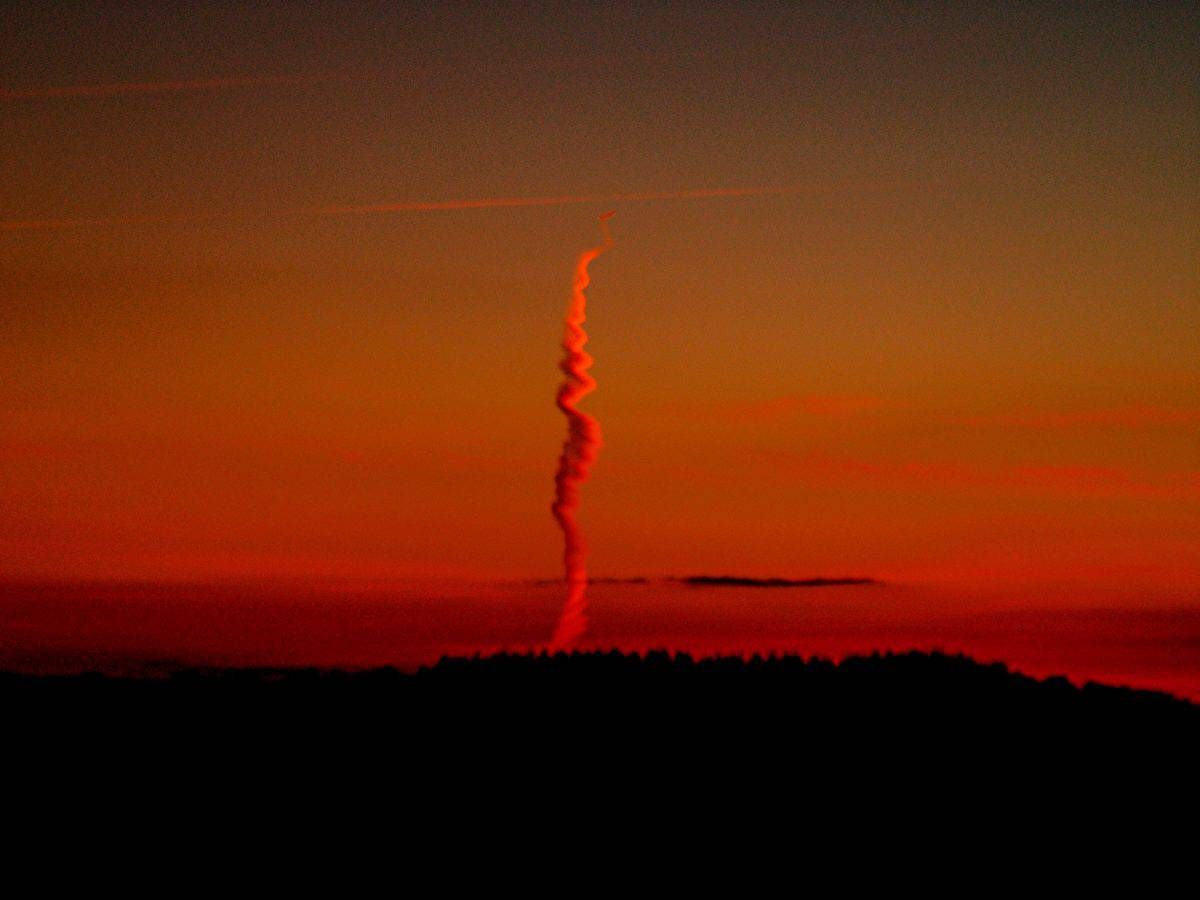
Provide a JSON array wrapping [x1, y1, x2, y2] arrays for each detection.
[[0, 185, 851, 232]]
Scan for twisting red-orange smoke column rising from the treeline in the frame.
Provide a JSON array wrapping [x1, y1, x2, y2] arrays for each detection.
[[550, 212, 612, 650]]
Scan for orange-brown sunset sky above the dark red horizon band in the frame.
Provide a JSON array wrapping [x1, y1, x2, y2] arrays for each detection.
[[0, 2, 1200, 691]]
